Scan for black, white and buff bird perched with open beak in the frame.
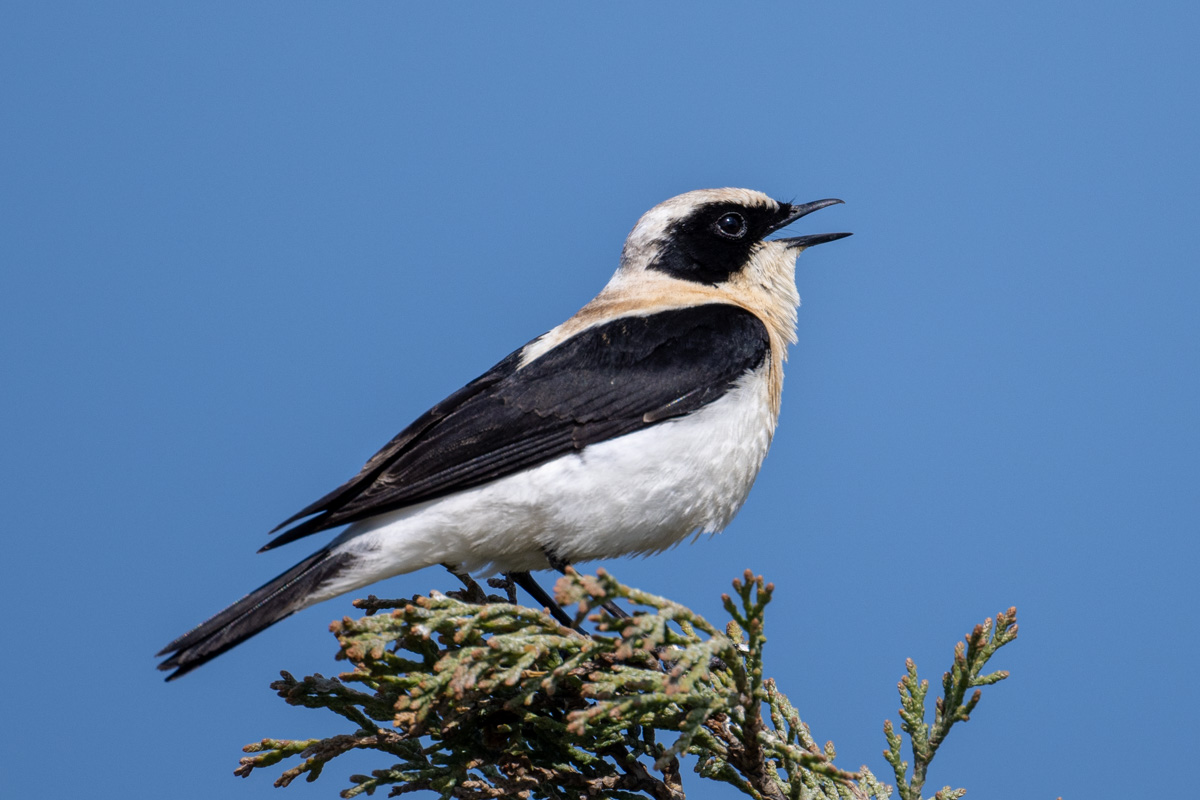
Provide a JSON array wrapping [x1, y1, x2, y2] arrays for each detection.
[[157, 188, 851, 680]]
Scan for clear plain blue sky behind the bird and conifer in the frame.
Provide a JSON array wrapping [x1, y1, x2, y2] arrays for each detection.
[[0, 1, 1200, 800]]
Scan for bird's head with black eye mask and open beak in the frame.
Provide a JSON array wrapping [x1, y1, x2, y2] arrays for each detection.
[[620, 188, 850, 285]]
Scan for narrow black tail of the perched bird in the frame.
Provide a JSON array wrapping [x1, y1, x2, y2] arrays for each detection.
[[157, 548, 354, 680]]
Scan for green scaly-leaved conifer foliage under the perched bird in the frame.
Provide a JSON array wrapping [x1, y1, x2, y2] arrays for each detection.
[[236, 570, 1015, 800]]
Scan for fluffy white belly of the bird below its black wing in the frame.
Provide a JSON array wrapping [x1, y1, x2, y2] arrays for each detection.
[[313, 365, 775, 602]]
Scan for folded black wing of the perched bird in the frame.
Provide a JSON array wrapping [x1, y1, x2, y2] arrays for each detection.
[[263, 303, 769, 551]]
